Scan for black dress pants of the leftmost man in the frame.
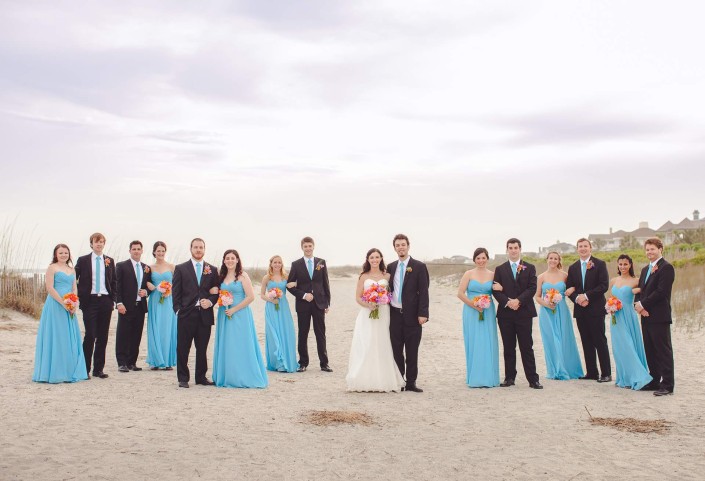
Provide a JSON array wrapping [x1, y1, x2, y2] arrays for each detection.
[[81, 295, 114, 373]]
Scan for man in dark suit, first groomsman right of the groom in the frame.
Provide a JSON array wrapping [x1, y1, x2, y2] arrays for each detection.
[[492, 238, 543, 389]]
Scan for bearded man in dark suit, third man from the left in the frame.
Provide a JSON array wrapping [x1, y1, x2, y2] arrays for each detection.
[[171, 238, 220, 388]]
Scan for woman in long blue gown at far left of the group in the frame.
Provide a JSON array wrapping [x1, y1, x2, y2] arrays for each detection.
[[32, 244, 88, 383]]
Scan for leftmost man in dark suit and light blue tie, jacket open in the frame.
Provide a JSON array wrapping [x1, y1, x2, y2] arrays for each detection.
[[75, 232, 117, 379]]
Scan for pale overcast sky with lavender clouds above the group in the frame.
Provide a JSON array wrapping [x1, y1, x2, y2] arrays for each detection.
[[0, 0, 705, 265]]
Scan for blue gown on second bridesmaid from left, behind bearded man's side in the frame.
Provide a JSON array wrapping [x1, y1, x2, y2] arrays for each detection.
[[147, 271, 176, 368]]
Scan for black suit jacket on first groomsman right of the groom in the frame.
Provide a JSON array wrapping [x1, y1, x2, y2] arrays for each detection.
[[492, 260, 536, 321]]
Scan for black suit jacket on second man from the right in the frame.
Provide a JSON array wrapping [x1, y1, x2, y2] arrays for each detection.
[[565, 256, 610, 319]]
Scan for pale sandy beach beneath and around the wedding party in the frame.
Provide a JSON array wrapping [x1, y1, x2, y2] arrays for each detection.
[[0, 278, 705, 480]]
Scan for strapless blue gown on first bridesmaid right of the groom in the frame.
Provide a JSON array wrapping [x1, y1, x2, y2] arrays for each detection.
[[463, 279, 499, 387]]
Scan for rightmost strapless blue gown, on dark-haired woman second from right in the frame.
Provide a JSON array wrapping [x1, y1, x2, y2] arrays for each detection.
[[609, 286, 652, 389]]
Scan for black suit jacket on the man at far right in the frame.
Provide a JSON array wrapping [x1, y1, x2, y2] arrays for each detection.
[[635, 258, 676, 324]]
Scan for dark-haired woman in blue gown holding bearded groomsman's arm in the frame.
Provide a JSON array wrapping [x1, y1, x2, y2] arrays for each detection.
[[213, 249, 268, 388]]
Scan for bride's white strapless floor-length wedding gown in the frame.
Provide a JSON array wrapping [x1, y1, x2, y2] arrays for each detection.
[[345, 279, 404, 392]]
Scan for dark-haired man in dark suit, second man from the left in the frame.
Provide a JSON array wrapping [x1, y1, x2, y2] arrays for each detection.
[[115, 241, 151, 372]]
